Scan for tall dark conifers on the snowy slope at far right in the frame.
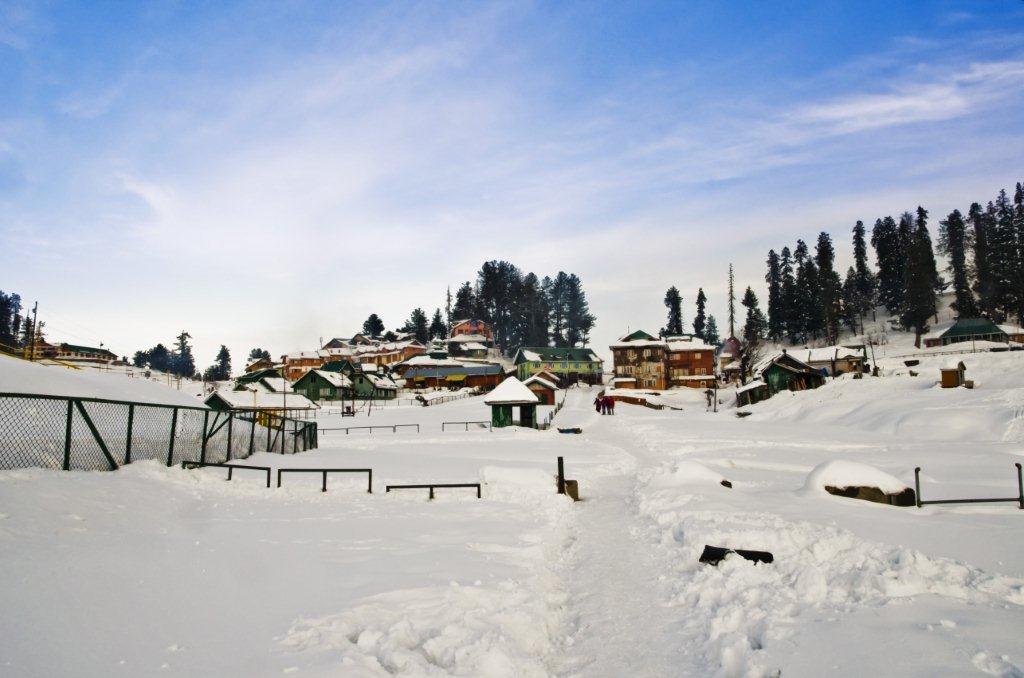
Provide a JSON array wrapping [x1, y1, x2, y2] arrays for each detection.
[[743, 183, 1024, 347]]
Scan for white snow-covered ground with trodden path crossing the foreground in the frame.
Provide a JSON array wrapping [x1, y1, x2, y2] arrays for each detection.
[[0, 353, 1024, 677]]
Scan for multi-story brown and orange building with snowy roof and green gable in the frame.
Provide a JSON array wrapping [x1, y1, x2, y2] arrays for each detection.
[[610, 330, 715, 389]]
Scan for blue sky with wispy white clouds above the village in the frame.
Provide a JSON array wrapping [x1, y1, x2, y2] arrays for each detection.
[[0, 0, 1024, 369]]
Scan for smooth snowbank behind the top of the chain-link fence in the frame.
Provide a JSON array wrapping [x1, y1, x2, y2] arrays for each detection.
[[0, 355, 203, 408]]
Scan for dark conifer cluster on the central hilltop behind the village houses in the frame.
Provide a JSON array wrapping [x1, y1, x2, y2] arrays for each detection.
[[362, 260, 596, 354]]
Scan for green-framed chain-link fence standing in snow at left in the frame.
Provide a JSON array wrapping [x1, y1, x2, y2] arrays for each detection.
[[0, 393, 317, 470]]
